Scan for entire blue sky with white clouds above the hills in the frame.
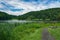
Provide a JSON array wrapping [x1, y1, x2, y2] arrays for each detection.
[[0, 0, 60, 15]]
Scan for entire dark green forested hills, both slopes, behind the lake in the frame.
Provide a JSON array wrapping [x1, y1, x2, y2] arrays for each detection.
[[0, 8, 60, 21]]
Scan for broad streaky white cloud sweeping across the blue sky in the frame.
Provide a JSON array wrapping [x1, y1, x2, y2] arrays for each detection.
[[0, 0, 60, 15]]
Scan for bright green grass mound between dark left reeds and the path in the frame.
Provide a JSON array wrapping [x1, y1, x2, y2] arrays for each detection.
[[11, 23, 42, 40]]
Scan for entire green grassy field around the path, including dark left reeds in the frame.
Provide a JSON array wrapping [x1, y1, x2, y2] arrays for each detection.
[[0, 22, 60, 40]]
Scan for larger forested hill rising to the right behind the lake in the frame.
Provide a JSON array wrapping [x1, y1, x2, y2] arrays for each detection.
[[18, 8, 60, 21]]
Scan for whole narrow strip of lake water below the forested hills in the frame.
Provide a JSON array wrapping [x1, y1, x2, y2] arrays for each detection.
[[0, 20, 60, 23]]
